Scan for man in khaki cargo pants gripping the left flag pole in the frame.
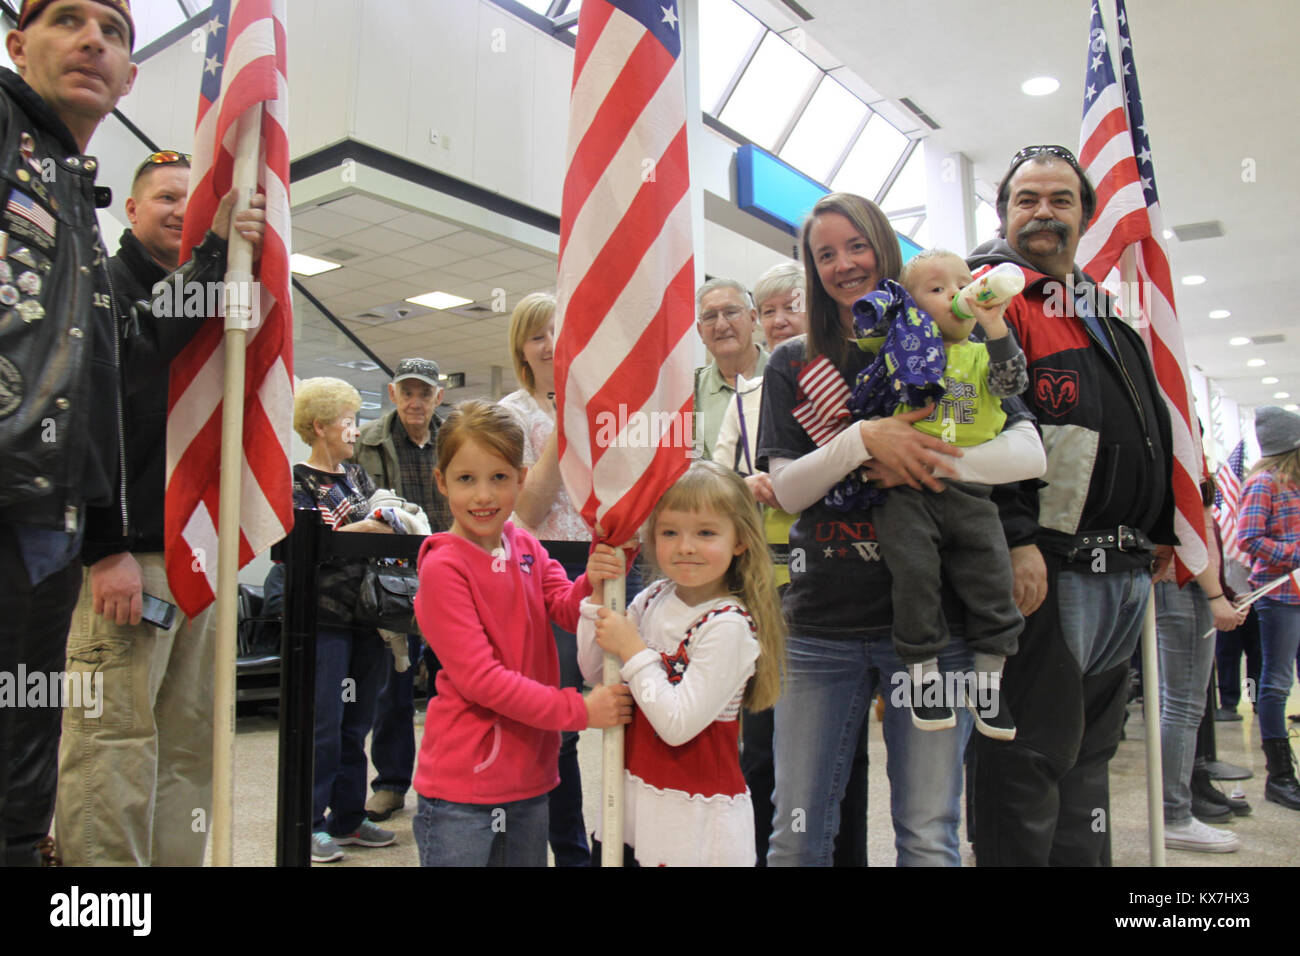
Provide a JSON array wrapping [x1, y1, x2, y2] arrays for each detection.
[[56, 150, 265, 866]]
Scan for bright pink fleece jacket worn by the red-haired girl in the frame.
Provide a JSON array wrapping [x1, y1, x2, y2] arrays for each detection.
[[415, 522, 592, 804]]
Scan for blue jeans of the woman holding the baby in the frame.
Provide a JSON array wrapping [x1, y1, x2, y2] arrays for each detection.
[[767, 635, 972, 866]]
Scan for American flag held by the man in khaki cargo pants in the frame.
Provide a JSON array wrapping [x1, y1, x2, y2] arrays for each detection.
[[166, 0, 294, 615]]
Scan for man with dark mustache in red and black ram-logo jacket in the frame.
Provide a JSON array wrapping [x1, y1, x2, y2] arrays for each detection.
[[969, 146, 1175, 866]]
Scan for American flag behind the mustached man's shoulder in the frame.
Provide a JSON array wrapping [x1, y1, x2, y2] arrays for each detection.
[[1078, 0, 1209, 584]]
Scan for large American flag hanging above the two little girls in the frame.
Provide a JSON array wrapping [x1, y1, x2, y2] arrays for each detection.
[[555, 0, 694, 544]]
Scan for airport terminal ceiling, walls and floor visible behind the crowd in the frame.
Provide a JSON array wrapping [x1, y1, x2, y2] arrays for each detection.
[[5, 0, 1300, 866]]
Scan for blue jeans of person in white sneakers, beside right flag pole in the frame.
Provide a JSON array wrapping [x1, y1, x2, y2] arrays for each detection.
[[1156, 581, 1214, 825]]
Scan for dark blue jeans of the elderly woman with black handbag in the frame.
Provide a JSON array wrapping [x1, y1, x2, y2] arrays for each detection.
[[312, 627, 393, 836]]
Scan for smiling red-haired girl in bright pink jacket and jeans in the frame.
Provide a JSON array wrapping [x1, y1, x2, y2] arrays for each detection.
[[413, 402, 632, 866]]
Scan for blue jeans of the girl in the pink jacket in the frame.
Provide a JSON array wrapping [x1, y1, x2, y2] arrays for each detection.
[[411, 793, 550, 866]]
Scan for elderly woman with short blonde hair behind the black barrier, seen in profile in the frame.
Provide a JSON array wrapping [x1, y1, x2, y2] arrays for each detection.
[[294, 377, 397, 862]]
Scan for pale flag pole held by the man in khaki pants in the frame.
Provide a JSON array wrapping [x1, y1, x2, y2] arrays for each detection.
[[212, 107, 261, 866]]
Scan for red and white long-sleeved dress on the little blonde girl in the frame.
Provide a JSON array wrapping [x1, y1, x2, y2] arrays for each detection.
[[577, 581, 758, 866]]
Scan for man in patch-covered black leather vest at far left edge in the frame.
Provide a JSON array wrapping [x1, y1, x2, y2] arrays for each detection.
[[0, 0, 135, 865]]
